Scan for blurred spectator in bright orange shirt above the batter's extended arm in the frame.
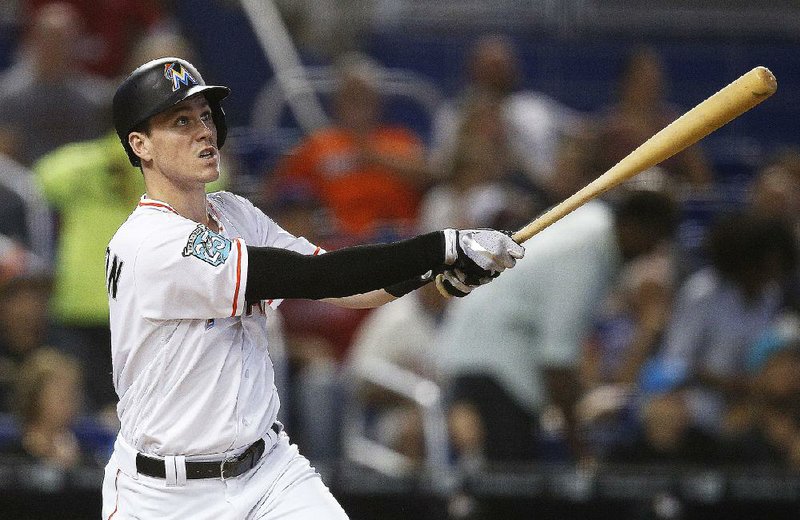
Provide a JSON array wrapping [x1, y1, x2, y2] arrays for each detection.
[[265, 55, 429, 239]]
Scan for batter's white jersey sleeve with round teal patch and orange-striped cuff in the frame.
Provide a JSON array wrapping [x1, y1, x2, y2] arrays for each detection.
[[134, 221, 247, 320]]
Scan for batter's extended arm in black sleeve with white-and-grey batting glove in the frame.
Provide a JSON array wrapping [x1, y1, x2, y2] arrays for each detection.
[[245, 229, 524, 301]]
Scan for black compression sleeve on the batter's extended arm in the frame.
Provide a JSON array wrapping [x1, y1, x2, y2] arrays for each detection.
[[245, 231, 445, 301]]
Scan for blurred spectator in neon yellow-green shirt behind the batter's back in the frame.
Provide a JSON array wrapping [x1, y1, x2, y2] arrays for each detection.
[[34, 133, 144, 411]]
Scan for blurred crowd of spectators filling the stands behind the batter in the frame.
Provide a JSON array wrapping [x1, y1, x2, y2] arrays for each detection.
[[0, 0, 800, 488]]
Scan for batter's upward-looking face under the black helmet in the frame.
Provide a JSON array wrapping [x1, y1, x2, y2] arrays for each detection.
[[141, 94, 219, 189]]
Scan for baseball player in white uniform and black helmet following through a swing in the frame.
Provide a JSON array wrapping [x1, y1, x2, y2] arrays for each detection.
[[103, 58, 524, 520]]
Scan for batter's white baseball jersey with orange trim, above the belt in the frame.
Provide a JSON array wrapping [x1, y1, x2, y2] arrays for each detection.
[[106, 192, 321, 456]]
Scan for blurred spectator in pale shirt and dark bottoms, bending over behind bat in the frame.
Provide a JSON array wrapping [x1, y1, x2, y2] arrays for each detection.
[[437, 192, 673, 460]]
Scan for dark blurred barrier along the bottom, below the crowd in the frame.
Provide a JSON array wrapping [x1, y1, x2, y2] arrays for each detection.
[[0, 459, 800, 520]]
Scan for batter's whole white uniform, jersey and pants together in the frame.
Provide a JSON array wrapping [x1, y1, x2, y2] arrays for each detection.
[[103, 192, 346, 520]]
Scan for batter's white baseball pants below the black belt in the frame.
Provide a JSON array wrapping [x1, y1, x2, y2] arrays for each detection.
[[103, 432, 347, 520]]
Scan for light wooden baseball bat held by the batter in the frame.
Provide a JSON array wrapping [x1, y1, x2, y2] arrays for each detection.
[[436, 67, 778, 295]]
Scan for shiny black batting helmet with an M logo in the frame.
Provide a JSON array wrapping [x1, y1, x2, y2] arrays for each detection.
[[113, 57, 230, 166]]
